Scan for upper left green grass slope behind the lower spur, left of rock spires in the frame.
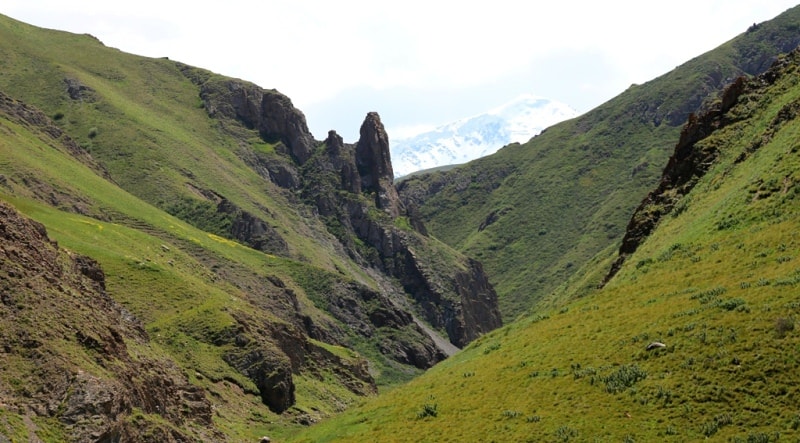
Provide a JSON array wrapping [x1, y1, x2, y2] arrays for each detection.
[[0, 17, 342, 270]]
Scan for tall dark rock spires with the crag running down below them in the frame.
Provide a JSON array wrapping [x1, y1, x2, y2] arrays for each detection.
[[304, 112, 502, 350]]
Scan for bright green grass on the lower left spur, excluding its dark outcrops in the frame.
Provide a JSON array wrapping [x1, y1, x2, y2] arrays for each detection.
[[0, 90, 382, 441]]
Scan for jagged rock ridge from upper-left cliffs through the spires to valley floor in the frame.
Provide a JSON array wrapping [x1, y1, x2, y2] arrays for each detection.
[[179, 65, 502, 350]]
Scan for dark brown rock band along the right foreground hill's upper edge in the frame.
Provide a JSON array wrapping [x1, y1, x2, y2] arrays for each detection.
[[602, 50, 800, 285]]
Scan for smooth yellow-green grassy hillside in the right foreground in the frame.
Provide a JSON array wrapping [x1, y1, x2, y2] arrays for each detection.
[[296, 48, 800, 442]]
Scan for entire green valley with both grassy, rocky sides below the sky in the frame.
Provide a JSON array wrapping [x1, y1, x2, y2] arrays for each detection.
[[0, 7, 800, 442]]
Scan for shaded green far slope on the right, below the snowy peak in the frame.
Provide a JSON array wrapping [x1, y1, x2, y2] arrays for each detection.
[[399, 8, 800, 319]]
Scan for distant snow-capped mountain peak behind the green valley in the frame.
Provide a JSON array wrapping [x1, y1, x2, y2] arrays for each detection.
[[391, 95, 577, 177]]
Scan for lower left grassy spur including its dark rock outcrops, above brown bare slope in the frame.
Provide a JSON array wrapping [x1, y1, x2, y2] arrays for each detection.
[[0, 86, 378, 441]]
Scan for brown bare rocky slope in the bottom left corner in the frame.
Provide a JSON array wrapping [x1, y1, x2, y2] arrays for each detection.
[[0, 203, 224, 442]]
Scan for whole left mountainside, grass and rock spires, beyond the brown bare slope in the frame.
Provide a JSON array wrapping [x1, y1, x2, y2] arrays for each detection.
[[0, 12, 500, 441]]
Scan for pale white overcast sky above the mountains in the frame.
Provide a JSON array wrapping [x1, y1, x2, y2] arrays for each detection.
[[0, 0, 798, 142]]
